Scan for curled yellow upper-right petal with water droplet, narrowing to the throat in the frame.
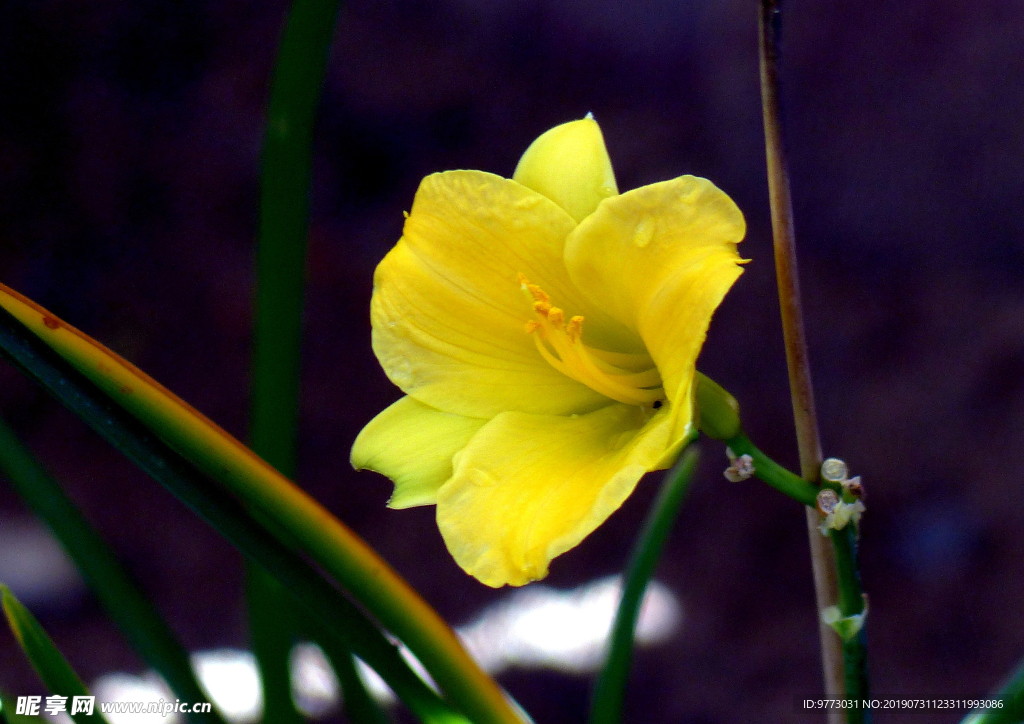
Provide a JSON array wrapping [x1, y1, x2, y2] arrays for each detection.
[[565, 176, 746, 435]]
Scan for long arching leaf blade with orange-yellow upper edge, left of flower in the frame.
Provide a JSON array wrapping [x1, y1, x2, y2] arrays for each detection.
[[0, 285, 520, 724]]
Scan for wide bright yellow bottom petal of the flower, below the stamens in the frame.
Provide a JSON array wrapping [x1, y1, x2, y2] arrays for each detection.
[[437, 402, 684, 587]]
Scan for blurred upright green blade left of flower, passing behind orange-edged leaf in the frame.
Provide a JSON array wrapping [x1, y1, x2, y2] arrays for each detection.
[[246, 0, 340, 712]]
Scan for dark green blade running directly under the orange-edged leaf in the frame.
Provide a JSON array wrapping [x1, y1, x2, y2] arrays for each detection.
[[0, 309, 468, 724]]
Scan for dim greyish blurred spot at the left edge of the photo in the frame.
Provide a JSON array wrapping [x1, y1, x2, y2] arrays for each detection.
[[0, 518, 85, 608]]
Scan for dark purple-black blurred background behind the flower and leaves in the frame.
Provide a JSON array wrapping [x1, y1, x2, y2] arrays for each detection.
[[0, 0, 1024, 724]]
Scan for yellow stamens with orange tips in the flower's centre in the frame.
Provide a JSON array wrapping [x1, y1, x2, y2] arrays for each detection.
[[519, 274, 665, 407]]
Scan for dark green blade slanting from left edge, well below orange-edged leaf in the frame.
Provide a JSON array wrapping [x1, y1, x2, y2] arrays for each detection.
[[0, 420, 223, 723]]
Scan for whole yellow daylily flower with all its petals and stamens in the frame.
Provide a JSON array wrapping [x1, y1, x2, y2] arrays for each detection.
[[352, 116, 745, 587]]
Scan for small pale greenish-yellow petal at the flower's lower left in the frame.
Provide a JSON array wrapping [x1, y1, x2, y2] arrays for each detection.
[[351, 396, 487, 508]]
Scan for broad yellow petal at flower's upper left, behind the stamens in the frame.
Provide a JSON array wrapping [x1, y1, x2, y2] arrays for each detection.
[[371, 171, 640, 418]]
